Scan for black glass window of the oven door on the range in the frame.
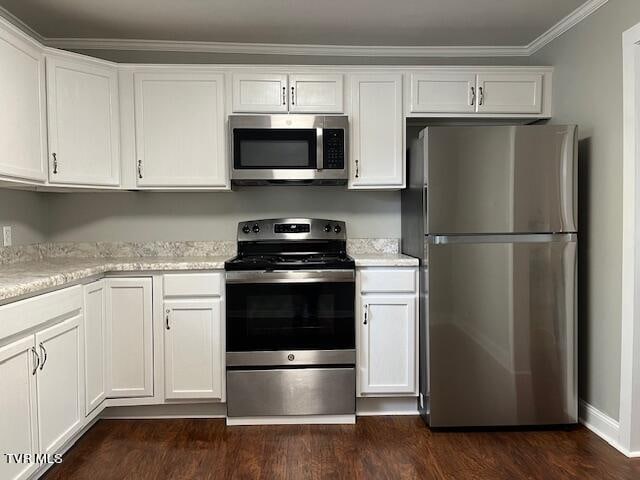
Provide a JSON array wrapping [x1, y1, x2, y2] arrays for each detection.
[[226, 283, 355, 352]]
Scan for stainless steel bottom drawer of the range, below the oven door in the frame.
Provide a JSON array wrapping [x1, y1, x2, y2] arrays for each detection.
[[227, 367, 356, 417]]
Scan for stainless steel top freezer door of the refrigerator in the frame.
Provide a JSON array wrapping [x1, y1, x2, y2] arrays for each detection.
[[423, 125, 577, 234]]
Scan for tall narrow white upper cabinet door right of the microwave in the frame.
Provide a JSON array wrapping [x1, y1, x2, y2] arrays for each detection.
[[350, 74, 405, 189]]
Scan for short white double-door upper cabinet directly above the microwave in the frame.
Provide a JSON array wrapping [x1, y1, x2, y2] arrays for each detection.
[[233, 73, 344, 113]]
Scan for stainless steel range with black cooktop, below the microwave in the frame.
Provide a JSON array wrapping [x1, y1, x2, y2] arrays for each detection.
[[225, 218, 355, 418]]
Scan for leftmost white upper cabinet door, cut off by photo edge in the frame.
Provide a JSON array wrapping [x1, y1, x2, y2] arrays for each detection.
[[0, 26, 46, 182]]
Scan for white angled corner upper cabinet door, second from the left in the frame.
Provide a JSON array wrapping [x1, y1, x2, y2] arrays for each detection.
[[47, 56, 120, 186]]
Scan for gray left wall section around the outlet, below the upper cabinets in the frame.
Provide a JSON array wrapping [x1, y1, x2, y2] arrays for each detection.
[[0, 189, 49, 245]]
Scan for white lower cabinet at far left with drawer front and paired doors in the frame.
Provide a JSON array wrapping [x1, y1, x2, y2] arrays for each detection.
[[0, 287, 85, 480]]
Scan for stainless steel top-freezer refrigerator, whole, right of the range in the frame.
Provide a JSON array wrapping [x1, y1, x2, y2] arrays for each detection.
[[402, 125, 578, 427]]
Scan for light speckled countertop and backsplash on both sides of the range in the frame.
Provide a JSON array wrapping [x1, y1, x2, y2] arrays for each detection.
[[0, 238, 418, 305]]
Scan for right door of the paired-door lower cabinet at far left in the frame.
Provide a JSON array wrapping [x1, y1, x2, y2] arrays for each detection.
[[36, 315, 84, 454]]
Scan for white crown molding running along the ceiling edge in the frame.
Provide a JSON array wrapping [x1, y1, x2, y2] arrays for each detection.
[[0, 0, 608, 58]]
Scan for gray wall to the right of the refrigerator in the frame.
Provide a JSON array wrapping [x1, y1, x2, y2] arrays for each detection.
[[530, 0, 640, 419]]
